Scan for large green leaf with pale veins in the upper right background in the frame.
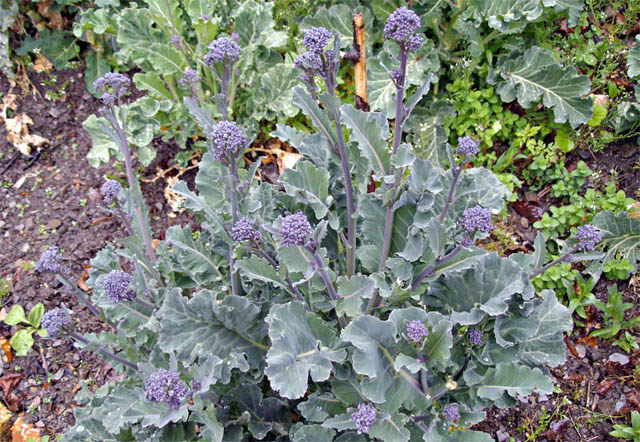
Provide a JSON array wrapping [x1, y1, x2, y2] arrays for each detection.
[[496, 46, 593, 128]]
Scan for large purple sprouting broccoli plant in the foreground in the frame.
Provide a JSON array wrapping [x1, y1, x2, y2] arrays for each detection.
[[47, 7, 599, 442]]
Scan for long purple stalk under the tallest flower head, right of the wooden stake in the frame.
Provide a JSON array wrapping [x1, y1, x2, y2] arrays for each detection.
[[365, 43, 407, 315]]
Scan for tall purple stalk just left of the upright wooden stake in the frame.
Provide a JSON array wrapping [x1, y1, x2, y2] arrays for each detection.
[[324, 73, 356, 278]]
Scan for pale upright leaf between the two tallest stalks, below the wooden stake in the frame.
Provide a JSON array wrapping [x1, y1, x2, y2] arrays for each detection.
[[340, 104, 391, 179]]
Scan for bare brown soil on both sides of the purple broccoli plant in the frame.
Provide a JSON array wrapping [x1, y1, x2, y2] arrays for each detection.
[[0, 64, 640, 442]]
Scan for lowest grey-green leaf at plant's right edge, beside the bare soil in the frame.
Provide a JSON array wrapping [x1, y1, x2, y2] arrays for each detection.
[[477, 363, 553, 400]]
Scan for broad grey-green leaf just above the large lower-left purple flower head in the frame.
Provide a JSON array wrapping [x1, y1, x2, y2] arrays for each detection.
[[158, 290, 266, 370]]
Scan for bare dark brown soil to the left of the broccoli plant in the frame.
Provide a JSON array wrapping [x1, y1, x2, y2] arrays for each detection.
[[0, 69, 195, 435]]
